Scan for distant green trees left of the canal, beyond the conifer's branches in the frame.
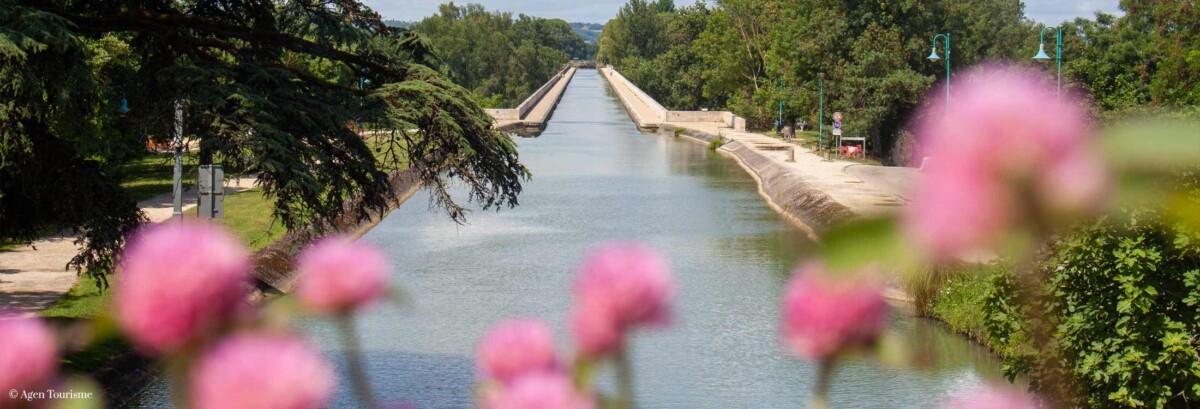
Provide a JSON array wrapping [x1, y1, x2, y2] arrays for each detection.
[[412, 2, 594, 108]]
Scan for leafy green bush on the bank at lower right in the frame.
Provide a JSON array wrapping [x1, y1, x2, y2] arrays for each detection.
[[924, 196, 1200, 408]]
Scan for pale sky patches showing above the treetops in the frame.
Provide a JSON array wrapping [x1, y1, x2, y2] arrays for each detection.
[[365, 0, 1120, 24]]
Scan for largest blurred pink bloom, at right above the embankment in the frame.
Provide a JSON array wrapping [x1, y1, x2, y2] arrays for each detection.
[[906, 66, 1106, 259]]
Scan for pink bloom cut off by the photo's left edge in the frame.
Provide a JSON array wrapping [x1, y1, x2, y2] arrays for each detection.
[[0, 317, 59, 391]]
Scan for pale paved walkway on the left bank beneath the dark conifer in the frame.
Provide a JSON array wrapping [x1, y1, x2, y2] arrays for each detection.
[[0, 178, 256, 315]]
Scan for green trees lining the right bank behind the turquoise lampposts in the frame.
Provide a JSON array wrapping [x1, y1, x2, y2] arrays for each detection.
[[598, 0, 1200, 164]]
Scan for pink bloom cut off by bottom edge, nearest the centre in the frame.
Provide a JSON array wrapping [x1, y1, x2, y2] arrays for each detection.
[[484, 372, 596, 409]]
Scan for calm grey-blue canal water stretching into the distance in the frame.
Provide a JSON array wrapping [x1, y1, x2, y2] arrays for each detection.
[[129, 70, 1000, 409]]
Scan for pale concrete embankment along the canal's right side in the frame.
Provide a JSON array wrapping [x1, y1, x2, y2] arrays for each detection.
[[601, 67, 917, 233]]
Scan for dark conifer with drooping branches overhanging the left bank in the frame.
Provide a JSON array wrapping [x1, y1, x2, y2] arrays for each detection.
[[0, 0, 528, 281]]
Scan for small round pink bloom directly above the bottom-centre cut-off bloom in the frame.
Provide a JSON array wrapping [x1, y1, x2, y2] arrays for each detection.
[[478, 319, 558, 384]]
